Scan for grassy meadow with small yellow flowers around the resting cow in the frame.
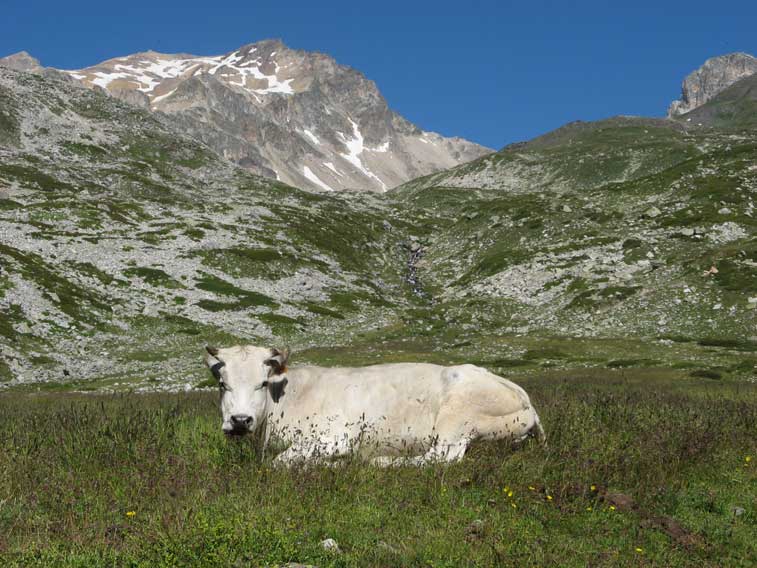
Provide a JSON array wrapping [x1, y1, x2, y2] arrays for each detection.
[[0, 366, 757, 567]]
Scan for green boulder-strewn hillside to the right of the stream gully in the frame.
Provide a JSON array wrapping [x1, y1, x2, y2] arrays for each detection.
[[392, 111, 757, 345]]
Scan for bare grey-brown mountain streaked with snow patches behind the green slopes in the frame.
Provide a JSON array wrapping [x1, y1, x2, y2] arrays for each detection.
[[0, 41, 489, 191]]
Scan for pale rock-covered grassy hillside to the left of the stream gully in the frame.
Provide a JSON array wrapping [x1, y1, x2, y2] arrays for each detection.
[[0, 68, 409, 388]]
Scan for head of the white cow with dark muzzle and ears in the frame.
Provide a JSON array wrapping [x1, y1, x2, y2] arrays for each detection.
[[205, 345, 289, 434]]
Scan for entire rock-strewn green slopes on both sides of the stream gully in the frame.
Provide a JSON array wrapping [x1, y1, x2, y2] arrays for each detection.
[[0, 56, 757, 389]]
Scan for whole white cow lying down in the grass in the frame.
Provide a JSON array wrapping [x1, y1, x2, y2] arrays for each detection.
[[206, 345, 545, 464]]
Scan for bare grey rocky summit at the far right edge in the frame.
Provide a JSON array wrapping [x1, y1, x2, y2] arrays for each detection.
[[668, 53, 757, 118]]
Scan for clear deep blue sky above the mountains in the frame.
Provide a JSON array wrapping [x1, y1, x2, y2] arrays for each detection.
[[0, 0, 757, 148]]
